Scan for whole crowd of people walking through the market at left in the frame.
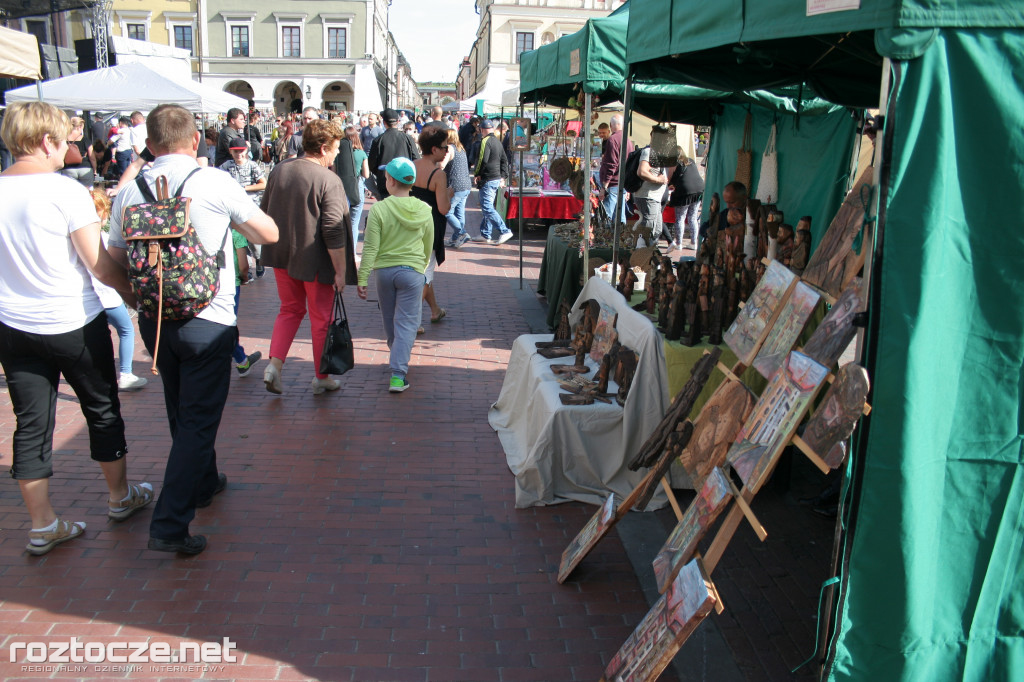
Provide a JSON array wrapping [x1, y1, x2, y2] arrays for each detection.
[[0, 96, 524, 555]]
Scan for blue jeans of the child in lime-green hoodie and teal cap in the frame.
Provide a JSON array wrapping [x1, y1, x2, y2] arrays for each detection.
[[374, 265, 427, 379]]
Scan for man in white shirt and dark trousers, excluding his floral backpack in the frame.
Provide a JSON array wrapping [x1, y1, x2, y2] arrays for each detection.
[[109, 104, 278, 554]]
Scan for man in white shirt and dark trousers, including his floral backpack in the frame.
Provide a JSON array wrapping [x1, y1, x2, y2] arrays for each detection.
[[109, 104, 278, 554]]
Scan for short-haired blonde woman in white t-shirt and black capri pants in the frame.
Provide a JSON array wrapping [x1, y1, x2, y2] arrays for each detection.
[[0, 101, 153, 555]]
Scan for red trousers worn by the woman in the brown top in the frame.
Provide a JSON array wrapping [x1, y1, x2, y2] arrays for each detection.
[[270, 268, 334, 379]]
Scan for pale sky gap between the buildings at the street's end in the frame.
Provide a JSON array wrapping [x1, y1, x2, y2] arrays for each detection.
[[389, 0, 480, 83]]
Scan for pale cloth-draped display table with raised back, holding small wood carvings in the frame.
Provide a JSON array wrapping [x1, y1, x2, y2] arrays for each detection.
[[487, 278, 669, 509]]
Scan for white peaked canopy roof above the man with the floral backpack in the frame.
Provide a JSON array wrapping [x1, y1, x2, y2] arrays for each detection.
[[7, 63, 249, 114]]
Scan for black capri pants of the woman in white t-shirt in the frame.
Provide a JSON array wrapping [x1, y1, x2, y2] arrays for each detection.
[[0, 312, 128, 479]]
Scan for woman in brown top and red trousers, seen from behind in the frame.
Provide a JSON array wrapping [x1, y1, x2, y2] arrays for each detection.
[[261, 120, 356, 394]]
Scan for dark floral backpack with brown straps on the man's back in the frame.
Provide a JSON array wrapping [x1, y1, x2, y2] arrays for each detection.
[[121, 168, 229, 374]]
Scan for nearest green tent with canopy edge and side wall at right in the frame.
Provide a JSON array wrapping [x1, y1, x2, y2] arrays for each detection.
[[628, 0, 1024, 682]]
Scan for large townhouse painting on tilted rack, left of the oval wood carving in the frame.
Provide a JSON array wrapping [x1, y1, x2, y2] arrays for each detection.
[[726, 350, 828, 493]]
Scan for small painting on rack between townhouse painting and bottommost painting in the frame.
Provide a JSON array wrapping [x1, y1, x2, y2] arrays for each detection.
[[651, 468, 732, 592]]
